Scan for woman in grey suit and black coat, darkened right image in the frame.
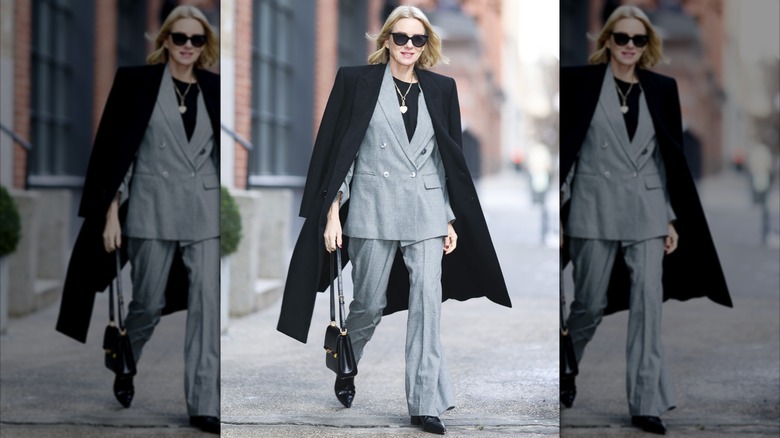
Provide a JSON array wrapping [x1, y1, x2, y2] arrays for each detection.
[[561, 6, 731, 434]]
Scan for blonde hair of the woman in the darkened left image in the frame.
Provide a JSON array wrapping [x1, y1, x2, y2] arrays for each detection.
[[146, 6, 219, 68]]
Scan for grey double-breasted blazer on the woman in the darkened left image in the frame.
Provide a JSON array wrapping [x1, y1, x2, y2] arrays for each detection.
[[120, 68, 220, 241]]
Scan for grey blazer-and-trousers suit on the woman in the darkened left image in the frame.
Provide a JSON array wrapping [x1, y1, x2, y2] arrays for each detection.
[[120, 68, 219, 417]]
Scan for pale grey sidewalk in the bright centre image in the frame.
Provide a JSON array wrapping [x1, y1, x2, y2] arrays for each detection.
[[222, 169, 559, 437]]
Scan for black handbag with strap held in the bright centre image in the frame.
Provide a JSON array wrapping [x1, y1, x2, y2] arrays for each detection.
[[324, 249, 357, 379]]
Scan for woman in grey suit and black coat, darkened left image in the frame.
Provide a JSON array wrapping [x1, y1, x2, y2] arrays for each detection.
[[57, 6, 219, 433]]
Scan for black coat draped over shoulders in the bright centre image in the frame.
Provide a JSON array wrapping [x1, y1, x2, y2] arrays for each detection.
[[277, 64, 512, 342]]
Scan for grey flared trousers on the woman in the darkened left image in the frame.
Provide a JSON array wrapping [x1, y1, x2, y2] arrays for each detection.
[[125, 238, 220, 417]]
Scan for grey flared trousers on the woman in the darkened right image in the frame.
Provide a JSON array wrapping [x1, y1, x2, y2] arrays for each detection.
[[567, 238, 674, 416]]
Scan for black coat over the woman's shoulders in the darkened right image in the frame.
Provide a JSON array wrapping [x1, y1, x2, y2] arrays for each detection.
[[560, 64, 732, 314]]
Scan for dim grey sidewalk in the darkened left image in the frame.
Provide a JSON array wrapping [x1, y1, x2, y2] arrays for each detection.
[[0, 269, 214, 438]]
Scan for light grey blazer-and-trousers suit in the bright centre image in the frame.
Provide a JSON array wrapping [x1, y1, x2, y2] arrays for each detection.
[[341, 63, 455, 416]]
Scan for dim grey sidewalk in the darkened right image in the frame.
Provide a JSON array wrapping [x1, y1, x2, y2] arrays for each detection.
[[561, 172, 780, 437]]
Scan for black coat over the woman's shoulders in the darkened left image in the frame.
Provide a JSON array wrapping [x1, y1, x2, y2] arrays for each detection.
[[57, 64, 220, 342]]
